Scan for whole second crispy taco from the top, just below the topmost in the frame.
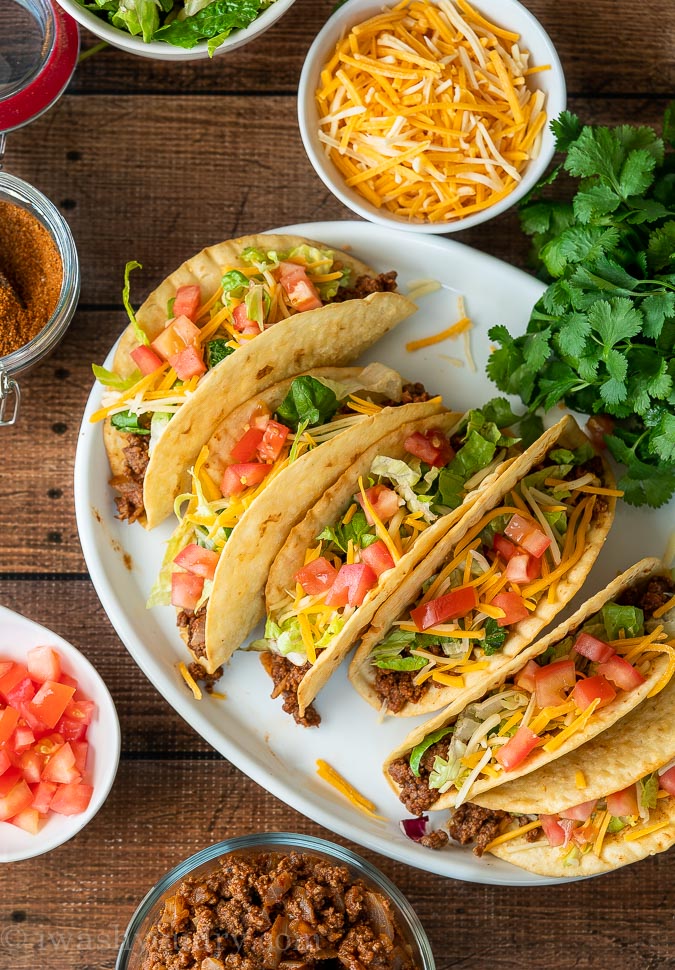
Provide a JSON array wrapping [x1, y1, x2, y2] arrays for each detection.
[[148, 364, 446, 674]]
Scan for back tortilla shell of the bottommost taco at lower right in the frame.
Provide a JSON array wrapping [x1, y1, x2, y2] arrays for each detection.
[[472, 660, 675, 815]]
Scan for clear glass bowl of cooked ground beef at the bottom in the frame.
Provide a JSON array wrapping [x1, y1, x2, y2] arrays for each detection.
[[116, 832, 436, 970]]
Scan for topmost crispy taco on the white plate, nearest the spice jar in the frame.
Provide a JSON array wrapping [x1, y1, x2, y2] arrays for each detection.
[[91, 234, 415, 528]]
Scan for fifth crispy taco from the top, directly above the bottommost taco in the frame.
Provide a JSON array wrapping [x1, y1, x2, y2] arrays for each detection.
[[384, 559, 675, 815]]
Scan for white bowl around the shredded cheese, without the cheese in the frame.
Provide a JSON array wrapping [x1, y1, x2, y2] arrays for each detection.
[[298, 0, 566, 233]]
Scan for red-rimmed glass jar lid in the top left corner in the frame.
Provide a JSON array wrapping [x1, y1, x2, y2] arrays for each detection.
[[0, 0, 80, 133]]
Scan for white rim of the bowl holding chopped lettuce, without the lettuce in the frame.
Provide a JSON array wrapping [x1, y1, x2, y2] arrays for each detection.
[[58, 0, 295, 61]]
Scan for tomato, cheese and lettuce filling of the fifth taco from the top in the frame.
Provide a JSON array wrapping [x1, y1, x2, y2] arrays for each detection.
[[389, 581, 675, 815]]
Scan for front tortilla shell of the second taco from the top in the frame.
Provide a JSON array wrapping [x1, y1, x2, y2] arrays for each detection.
[[206, 394, 448, 672]]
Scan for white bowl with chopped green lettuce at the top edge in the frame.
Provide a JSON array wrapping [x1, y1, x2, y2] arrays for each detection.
[[58, 0, 295, 61]]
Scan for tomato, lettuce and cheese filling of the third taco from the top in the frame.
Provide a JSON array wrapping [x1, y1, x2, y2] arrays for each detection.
[[255, 401, 532, 704]]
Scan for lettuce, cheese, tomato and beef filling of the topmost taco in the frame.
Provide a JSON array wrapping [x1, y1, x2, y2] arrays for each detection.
[[91, 250, 396, 521]]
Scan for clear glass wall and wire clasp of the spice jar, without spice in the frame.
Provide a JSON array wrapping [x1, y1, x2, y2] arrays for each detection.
[[0, 172, 80, 427]]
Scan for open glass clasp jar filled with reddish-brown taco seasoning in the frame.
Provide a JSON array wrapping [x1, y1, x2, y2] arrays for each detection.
[[0, 172, 80, 426]]
